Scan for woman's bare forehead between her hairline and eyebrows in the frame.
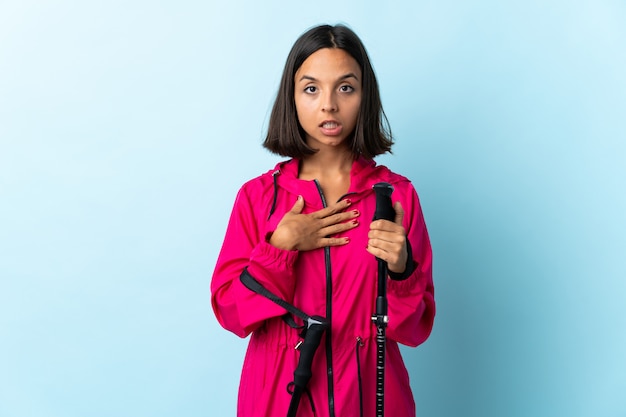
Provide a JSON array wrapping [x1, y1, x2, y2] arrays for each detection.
[[295, 48, 361, 82]]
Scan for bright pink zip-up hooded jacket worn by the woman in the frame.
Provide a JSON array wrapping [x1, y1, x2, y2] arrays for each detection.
[[211, 158, 435, 417]]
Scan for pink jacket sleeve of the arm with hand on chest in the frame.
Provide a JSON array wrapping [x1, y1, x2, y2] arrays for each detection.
[[211, 183, 298, 337]]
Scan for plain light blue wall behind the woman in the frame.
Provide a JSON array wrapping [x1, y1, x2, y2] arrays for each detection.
[[0, 0, 626, 417]]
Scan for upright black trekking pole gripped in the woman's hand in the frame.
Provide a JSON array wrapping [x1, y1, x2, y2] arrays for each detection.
[[372, 182, 396, 417]]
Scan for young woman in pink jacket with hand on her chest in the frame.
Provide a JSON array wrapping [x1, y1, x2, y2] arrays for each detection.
[[211, 25, 435, 417]]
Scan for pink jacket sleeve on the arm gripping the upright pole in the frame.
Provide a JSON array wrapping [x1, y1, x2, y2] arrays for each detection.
[[387, 185, 435, 347]]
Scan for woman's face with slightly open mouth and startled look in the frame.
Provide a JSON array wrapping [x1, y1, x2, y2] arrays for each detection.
[[294, 48, 362, 150]]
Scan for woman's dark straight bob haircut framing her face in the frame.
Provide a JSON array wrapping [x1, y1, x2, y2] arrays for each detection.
[[263, 25, 393, 159]]
